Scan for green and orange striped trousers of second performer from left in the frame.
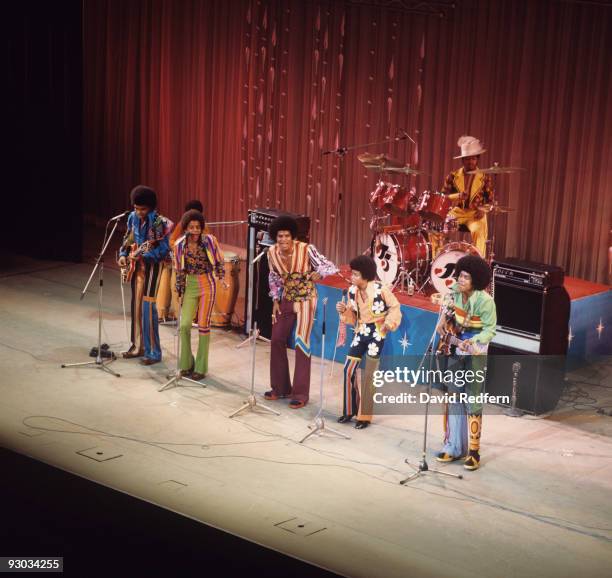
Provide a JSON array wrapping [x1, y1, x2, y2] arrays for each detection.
[[179, 275, 215, 374]]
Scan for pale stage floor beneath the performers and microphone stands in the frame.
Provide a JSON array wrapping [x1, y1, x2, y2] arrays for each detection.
[[0, 259, 612, 578]]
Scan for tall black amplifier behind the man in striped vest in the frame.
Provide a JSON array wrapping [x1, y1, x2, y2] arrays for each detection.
[[244, 208, 310, 339]]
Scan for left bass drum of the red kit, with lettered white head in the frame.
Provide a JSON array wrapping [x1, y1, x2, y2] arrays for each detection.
[[370, 231, 431, 285]]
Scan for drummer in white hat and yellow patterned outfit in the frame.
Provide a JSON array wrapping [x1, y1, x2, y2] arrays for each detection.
[[442, 136, 493, 257]]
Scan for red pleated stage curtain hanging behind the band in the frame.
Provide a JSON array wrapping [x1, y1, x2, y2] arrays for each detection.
[[84, 0, 612, 281]]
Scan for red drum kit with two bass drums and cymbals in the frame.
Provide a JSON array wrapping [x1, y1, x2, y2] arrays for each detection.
[[357, 153, 521, 295]]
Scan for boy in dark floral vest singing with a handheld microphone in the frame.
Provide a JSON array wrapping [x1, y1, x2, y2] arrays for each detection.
[[336, 255, 402, 429]]
